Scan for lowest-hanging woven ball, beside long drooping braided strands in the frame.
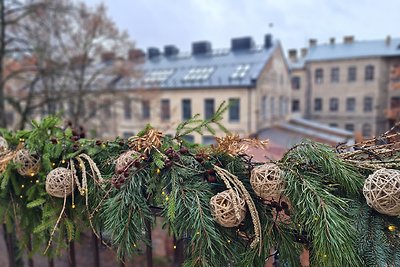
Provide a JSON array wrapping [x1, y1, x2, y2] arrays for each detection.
[[210, 189, 246, 227]]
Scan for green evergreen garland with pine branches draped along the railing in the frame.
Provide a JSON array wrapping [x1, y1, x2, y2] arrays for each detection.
[[0, 110, 400, 266]]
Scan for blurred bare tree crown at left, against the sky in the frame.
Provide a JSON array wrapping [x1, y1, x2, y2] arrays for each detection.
[[0, 0, 133, 128]]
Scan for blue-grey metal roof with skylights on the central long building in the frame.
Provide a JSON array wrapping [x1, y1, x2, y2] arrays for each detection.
[[115, 41, 280, 89]]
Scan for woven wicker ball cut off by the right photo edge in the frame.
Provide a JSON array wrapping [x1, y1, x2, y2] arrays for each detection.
[[363, 169, 400, 216]]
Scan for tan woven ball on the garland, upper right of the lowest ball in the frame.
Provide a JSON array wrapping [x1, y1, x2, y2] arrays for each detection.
[[250, 163, 285, 199]]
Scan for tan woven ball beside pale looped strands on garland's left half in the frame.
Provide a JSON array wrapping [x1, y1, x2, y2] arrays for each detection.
[[46, 167, 75, 198]]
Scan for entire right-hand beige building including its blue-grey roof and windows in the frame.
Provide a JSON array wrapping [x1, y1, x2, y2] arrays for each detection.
[[289, 36, 400, 137]]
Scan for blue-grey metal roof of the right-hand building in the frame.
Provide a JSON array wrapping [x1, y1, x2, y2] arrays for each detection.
[[306, 38, 400, 61]]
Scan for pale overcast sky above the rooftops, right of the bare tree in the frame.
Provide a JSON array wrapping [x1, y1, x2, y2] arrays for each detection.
[[85, 0, 400, 54]]
